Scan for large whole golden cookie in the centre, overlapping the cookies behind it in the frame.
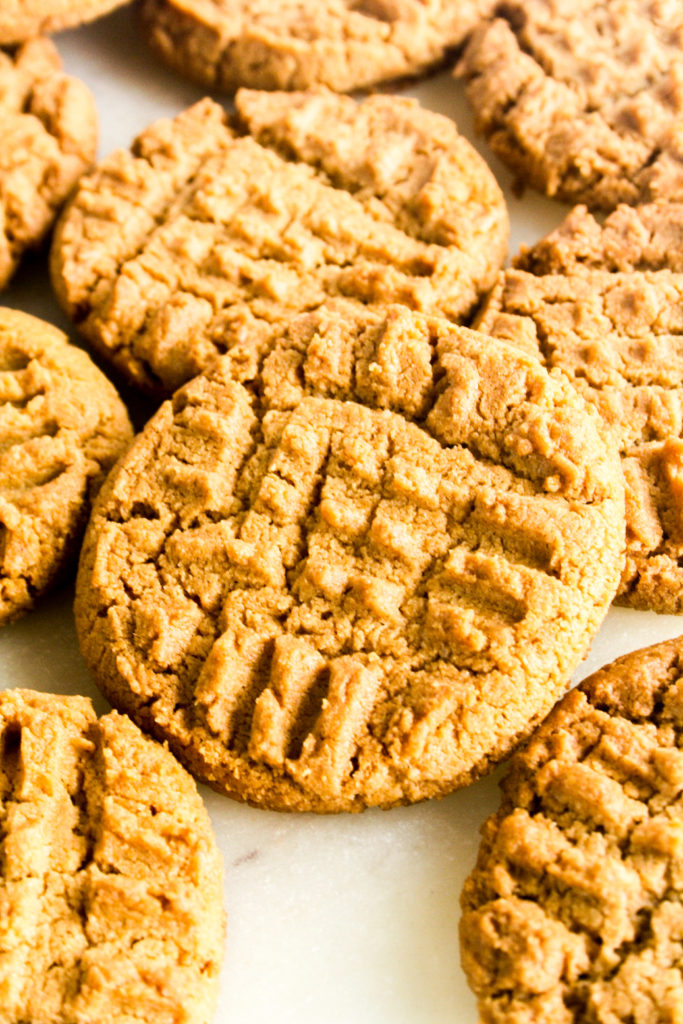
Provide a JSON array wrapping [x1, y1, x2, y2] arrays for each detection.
[[75, 303, 624, 811]]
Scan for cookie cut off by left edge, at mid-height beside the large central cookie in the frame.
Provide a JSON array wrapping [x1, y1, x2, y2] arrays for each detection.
[[0, 308, 132, 624]]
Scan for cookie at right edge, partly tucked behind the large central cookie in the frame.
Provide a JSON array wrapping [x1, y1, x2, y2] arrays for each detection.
[[479, 202, 683, 612]]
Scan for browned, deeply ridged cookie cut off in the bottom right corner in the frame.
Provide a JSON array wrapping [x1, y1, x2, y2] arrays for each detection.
[[461, 638, 683, 1024]]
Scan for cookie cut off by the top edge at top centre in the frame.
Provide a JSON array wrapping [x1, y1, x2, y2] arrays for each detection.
[[141, 0, 494, 92]]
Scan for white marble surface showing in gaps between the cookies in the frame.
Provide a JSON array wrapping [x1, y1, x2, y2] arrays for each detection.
[[0, 8, 683, 1024]]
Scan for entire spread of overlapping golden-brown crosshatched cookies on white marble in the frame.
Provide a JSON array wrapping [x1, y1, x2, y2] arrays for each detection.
[[0, 0, 683, 1024]]
